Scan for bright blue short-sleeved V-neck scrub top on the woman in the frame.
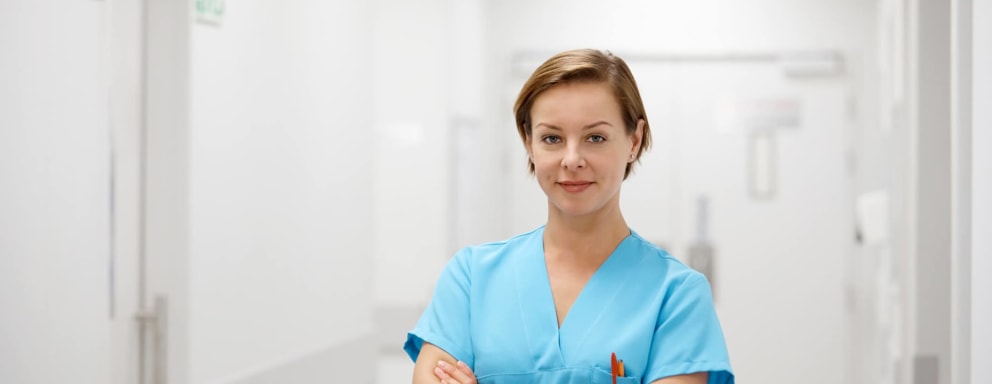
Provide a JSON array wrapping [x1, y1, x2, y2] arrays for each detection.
[[404, 226, 734, 384]]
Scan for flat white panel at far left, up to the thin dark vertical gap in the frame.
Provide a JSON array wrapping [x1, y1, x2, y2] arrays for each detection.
[[0, 1, 112, 383]]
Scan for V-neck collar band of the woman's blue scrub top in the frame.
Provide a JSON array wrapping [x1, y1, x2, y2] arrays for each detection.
[[516, 227, 637, 369]]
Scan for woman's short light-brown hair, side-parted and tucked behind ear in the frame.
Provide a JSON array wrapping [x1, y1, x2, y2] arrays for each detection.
[[513, 49, 651, 179]]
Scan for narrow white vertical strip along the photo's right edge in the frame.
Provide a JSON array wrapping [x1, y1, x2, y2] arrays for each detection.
[[971, 0, 992, 384]]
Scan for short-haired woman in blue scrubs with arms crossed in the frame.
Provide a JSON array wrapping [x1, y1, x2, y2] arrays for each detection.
[[404, 50, 734, 384]]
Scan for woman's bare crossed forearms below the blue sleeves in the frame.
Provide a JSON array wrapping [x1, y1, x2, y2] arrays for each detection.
[[413, 342, 709, 384]]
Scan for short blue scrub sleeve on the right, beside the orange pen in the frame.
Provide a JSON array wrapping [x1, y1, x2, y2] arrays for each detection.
[[644, 271, 734, 384]]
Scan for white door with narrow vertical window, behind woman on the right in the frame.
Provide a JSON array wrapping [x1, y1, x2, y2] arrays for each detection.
[[622, 60, 854, 384]]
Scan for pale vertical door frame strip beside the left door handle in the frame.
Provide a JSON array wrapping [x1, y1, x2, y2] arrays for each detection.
[[142, 1, 193, 384]]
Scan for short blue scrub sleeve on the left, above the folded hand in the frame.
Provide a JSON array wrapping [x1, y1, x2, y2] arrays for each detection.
[[403, 248, 475, 367]]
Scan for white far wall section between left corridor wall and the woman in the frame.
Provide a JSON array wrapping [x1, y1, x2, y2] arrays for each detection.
[[371, 0, 500, 353]]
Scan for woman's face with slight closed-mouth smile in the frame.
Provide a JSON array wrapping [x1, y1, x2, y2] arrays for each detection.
[[526, 82, 643, 216]]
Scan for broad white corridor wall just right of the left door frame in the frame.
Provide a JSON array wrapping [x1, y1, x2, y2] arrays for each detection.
[[188, 0, 376, 383]]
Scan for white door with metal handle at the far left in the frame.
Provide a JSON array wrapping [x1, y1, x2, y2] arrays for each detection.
[[0, 0, 171, 384]]
